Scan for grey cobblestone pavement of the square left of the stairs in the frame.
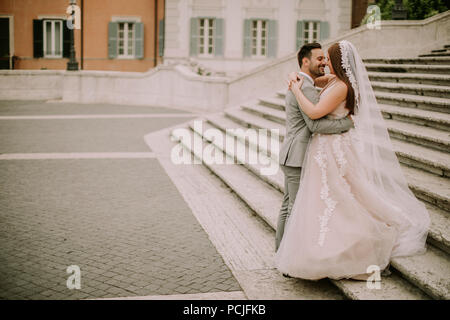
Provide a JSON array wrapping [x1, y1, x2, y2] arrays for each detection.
[[0, 102, 241, 299]]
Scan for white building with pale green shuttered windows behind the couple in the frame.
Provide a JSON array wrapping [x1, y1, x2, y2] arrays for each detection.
[[164, 0, 352, 75]]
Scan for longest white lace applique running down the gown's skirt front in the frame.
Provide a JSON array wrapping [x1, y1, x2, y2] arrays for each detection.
[[314, 135, 337, 247]]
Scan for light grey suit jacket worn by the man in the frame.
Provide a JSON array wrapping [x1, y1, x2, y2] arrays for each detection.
[[279, 77, 353, 167]]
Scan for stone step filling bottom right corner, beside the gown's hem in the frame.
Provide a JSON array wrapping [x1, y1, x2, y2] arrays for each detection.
[[391, 246, 450, 300]]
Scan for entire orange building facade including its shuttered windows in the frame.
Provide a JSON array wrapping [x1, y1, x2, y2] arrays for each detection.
[[0, 0, 164, 72]]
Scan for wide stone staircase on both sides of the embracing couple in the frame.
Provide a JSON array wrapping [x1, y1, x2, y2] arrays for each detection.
[[172, 46, 450, 299]]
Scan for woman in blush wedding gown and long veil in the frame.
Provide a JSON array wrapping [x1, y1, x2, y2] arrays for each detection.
[[275, 41, 430, 280]]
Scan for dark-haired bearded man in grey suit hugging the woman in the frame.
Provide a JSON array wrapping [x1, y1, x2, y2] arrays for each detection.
[[275, 43, 353, 250]]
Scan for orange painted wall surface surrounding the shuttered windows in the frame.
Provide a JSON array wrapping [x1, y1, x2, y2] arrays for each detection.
[[0, 0, 164, 72]]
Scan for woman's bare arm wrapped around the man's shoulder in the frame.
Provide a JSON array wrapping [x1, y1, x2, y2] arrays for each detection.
[[290, 77, 347, 120]]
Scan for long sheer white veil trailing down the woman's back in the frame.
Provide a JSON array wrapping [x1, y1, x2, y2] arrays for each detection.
[[339, 40, 430, 257]]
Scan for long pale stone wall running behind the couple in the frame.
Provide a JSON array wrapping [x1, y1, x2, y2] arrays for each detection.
[[0, 11, 450, 112]]
